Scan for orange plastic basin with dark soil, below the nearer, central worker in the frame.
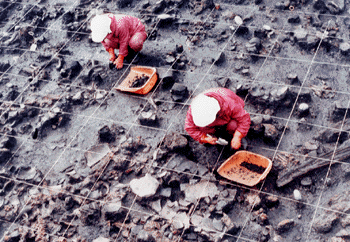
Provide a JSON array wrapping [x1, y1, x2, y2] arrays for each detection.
[[218, 150, 272, 186]]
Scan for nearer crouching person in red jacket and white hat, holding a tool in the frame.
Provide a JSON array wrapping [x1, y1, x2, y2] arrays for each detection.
[[185, 88, 250, 149]]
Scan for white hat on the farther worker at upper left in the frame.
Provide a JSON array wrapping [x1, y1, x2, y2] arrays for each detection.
[[91, 14, 112, 42]]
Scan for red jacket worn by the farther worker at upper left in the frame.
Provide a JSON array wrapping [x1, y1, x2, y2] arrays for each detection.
[[102, 13, 145, 57]]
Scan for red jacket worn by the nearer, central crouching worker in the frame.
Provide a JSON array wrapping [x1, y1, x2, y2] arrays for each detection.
[[185, 88, 250, 141]]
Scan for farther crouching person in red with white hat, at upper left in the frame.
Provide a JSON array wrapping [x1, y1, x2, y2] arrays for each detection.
[[91, 13, 147, 69]]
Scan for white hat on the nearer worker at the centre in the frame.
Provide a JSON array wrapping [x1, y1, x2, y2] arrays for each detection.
[[191, 94, 220, 127]]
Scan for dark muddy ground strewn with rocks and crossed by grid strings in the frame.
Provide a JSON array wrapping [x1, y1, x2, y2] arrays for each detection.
[[0, 0, 350, 242]]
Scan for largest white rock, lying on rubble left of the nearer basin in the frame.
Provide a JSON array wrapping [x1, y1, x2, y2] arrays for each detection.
[[130, 173, 159, 197]]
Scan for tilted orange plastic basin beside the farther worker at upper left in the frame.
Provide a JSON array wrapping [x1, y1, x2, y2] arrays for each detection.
[[116, 66, 158, 94]]
